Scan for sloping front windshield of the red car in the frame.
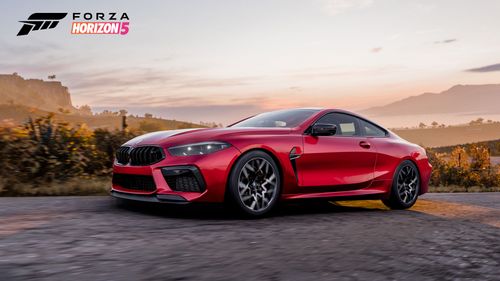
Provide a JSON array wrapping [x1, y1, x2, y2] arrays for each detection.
[[231, 109, 319, 128]]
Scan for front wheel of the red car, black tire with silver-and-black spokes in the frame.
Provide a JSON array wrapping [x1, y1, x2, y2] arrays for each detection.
[[227, 150, 281, 217]]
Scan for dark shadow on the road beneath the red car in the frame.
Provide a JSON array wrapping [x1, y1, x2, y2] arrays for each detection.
[[111, 196, 387, 220]]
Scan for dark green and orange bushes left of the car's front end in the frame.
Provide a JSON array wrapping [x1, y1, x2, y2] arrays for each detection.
[[0, 115, 135, 195]]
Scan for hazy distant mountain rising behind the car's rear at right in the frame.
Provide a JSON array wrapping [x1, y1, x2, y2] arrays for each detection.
[[362, 84, 500, 116]]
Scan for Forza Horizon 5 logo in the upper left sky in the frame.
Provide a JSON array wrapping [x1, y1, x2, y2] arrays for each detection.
[[17, 13, 130, 36]]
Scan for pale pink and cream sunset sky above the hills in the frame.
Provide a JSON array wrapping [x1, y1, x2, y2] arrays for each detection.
[[0, 0, 500, 124]]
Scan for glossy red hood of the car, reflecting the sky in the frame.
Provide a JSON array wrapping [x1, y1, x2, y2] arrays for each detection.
[[124, 127, 291, 146]]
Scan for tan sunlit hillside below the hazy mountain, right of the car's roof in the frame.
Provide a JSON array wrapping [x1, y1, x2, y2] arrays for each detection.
[[393, 122, 500, 147]]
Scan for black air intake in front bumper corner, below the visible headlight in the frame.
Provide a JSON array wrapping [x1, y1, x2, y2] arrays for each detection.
[[162, 167, 205, 192]]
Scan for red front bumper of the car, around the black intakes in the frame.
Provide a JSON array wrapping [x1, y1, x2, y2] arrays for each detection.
[[111, 147, 240, 203]]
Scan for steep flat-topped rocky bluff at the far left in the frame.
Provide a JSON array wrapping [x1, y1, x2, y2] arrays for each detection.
[[0, 74, 76, 112]]
